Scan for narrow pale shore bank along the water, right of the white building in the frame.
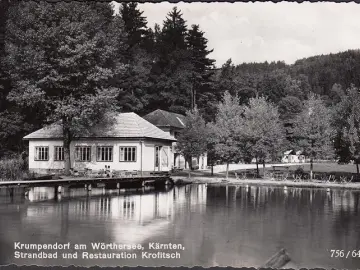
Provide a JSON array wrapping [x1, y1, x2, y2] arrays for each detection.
[[171, 176, 360, 190]]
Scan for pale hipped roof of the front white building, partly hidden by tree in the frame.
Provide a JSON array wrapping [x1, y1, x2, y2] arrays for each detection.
[[24, 112, 176, 141]]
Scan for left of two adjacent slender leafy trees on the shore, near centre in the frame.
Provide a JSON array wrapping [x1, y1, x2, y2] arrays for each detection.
[[209, 91, 244, 179]]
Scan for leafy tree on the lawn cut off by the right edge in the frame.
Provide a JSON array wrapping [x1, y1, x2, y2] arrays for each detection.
[[334, 85, 360, 173]]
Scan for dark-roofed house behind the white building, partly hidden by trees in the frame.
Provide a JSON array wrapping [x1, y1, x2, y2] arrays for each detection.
[[143, 109, 207, 169]]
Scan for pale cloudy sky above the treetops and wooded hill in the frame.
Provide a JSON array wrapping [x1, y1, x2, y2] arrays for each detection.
[[114, 2, 360, 67]]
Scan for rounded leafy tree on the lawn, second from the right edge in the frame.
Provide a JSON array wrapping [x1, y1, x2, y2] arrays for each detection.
[[295, 94, 333, 179]]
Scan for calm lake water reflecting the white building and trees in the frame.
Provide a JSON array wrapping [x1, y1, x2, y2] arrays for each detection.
[[0, 185, 360, 269]]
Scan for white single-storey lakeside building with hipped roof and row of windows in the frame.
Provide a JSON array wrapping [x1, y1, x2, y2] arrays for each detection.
[[24, 113, 176, 173]]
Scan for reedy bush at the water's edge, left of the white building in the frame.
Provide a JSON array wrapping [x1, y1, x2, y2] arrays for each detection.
[[0, 156, 27, 181]]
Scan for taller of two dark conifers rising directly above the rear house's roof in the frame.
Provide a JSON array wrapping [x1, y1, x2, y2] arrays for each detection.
[[149, 7, 192, 113]]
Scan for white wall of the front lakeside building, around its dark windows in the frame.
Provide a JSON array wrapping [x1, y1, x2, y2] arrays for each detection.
[[29, 140, 173, 172]]
